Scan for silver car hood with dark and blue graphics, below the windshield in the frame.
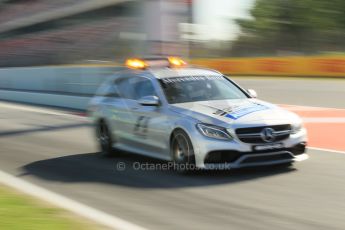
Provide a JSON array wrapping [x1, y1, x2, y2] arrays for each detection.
[[172, 99, 301, 128]]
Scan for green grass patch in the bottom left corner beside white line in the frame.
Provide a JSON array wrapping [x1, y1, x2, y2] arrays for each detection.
[[0, 186, 92, 230]]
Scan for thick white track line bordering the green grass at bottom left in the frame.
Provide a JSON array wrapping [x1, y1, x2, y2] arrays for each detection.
[[0, 171, 145, 230]]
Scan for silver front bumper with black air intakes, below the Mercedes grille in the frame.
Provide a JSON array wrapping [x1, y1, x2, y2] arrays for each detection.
[[193, 127, 309, 169]]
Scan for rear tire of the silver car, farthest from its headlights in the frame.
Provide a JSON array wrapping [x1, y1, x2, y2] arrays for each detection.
[[96, 121, 114, 157]]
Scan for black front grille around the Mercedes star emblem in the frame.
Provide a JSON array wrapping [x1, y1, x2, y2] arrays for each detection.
[[235, 124, 291, 144]]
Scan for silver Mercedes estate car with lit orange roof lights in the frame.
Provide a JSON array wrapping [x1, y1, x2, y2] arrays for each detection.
[[88, 57, 308, 169]]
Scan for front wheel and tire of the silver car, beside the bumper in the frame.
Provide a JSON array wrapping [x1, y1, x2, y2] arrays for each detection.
[[170, 130, 196, 174]]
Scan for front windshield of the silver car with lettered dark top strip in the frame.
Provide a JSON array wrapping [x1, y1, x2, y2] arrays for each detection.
[[160, 76, 247, 104]]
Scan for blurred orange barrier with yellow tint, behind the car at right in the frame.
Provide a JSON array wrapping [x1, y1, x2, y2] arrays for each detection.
[[191, 55, 345, 78]]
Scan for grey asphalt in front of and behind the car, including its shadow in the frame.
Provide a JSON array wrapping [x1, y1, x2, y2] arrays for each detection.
[[0, 78, 345, 230]]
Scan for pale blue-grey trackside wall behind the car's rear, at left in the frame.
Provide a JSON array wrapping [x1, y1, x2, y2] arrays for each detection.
[[0, 66, 122, 110]]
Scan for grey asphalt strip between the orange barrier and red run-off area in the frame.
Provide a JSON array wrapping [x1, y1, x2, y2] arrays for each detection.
[[233, 77, 345, 109]]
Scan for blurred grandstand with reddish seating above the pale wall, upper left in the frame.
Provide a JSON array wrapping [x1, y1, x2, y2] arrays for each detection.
[[0, 0, 188, 67]]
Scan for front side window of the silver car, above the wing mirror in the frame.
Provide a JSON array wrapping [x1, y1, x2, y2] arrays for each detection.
[[132, 77, 157, 100]]
